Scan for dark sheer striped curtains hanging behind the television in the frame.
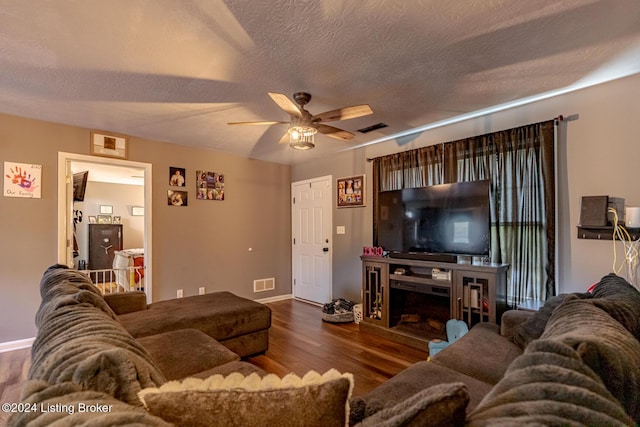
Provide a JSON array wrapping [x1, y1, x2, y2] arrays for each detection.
[[373, 120, 555, 304]]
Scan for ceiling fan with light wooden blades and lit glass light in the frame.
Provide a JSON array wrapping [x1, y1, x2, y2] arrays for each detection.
[[228, 92, 373, 150]]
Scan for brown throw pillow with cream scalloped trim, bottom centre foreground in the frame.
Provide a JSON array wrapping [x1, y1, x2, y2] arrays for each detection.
[[138, 369, 353, 427]]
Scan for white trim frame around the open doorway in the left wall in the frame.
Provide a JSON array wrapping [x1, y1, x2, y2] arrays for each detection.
[[58, 152, 153, 303]]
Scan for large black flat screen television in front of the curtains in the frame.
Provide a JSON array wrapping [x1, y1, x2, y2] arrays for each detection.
[[376, 180, 491, 257]]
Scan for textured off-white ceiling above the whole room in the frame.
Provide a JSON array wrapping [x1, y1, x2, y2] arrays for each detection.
[[0, 0, 640, 164]]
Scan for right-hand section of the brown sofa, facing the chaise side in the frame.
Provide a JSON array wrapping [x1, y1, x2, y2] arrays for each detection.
[[350, 275, 640, 426]]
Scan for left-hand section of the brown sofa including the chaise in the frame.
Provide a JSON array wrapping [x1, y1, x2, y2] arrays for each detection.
[[9, 265, 271, 426]]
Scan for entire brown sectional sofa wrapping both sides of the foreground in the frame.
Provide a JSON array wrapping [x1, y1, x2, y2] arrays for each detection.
[[9, 266, 640, 427]]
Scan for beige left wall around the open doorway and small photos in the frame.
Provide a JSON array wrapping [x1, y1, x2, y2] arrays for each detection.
[[0, 114, 291, 343]]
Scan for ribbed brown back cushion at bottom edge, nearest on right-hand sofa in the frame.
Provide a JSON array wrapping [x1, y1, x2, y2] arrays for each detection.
[[467, 339, 633, 427]]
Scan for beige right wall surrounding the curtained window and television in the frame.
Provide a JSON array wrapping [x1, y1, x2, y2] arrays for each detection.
[[292, 75, 640, 298]]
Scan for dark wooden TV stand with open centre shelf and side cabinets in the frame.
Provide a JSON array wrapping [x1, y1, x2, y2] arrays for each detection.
[[360, 256, 509, 350]]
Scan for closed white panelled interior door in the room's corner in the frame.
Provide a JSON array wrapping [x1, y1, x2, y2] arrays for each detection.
[[291, 176, 333, 304]]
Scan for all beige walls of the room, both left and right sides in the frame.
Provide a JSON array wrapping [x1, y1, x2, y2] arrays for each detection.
[[5, 75, 640, 342]]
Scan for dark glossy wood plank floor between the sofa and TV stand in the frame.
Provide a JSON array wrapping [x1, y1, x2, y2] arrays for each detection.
[[0, 300, 427, 425]]
